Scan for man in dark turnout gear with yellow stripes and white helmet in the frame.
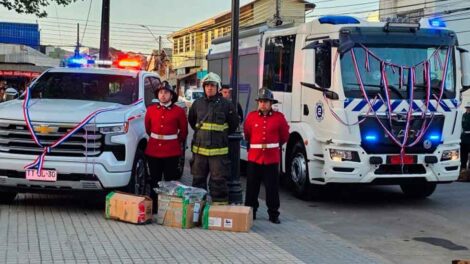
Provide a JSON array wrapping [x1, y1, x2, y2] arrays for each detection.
[[188, 73, 239, 203]]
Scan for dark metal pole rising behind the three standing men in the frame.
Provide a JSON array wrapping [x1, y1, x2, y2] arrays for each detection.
[[228, 0, 243, 204]]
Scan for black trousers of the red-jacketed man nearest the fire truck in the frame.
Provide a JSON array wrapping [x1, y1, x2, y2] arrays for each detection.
[[245, 162, 280, 217]]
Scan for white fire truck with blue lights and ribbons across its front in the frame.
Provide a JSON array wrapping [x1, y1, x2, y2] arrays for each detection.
[[207, 16, 470, 198]]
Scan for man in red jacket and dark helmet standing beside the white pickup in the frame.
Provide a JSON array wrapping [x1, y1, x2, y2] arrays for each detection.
[[145, 82, 188, 208]]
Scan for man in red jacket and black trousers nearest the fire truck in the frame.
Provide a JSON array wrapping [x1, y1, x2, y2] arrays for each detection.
[[244, 88, 289, 224]]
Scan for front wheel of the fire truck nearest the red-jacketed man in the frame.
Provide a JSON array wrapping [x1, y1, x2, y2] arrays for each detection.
[[286, 142, 311, 200]]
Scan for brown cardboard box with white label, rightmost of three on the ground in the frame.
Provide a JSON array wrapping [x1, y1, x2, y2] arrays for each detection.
[[202, 205, 253, 232]]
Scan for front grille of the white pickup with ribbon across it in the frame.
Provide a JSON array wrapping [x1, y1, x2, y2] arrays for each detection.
[[0, 123, 104, 157]]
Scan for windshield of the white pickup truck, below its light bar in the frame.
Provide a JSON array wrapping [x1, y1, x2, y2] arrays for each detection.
[[30, 72, 138, 105]]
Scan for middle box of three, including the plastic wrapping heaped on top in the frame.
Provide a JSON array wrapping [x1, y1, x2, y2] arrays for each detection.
[[155, 181, 206, 229]]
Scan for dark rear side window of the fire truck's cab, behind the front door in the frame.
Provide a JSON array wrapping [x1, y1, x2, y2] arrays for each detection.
[[263, 35, 295, 92]]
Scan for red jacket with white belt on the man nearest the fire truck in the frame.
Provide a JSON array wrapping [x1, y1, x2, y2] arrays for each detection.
[[243, 111, 289, 165]]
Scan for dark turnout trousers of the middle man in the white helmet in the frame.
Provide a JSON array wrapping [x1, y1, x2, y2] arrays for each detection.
[[190, 153, 231, 202]]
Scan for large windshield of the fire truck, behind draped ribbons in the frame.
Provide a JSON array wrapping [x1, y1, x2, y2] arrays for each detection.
[[341, 44, 455, 100]]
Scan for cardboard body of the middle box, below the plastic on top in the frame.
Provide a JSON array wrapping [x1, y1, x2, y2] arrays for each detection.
[[157, 194, 204, 229]]
